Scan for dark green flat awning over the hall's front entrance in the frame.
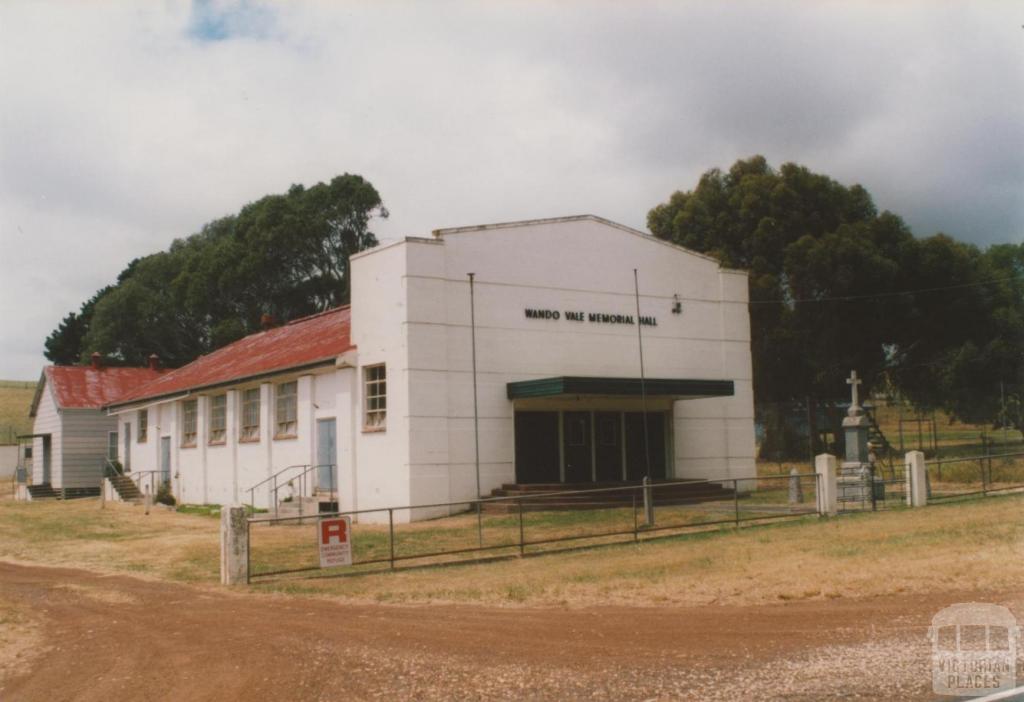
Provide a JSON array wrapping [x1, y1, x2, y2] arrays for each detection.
[[506, 376, 735, 400]]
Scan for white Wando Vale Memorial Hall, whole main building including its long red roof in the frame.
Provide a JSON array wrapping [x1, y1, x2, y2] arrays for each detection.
[[109, 215, 755, 520]]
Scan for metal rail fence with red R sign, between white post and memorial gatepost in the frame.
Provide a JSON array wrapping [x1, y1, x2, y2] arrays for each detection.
[[248, 473, 819, 581]]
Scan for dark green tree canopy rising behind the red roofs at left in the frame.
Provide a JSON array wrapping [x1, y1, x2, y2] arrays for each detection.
[[46, 174, 388, 366]]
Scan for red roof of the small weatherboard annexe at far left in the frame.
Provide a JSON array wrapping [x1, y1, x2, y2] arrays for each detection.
[[43, 365, 165, 409]]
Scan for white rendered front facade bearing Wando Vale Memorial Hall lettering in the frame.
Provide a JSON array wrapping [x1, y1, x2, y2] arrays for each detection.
[[352, 214, 755, 516]]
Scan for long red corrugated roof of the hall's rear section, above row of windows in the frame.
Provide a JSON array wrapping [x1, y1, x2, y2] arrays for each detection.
[[110, 305, 352, 404]]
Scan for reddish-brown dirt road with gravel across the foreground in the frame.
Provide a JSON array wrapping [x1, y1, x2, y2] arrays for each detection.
[[0, 563, 1024, 702]]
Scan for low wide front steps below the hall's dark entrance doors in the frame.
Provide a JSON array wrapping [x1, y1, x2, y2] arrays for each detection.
[[483, 480, 733, 514]]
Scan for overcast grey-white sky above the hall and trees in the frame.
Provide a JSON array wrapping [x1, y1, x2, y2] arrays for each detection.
[[0, 0, 1024, 379]]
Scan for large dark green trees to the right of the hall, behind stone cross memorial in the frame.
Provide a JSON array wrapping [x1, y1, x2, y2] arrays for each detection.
[[647, 156, 1024, 437]]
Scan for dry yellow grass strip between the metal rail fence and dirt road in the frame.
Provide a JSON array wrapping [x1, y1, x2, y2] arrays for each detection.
[[262, 495, 1024, 606]]
